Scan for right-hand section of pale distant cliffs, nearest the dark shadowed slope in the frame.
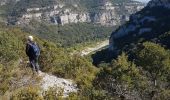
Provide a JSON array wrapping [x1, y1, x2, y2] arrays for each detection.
[[91, 2, 144, 26]]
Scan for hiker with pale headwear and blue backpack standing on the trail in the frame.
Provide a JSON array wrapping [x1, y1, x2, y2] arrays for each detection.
[[26, 36, 40, 73]]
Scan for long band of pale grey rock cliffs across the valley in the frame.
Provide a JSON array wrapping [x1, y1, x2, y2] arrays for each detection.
[[6, 0, 145, 26]]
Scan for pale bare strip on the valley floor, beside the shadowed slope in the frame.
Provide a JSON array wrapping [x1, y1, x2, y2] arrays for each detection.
[[81, 40, 109, 56]]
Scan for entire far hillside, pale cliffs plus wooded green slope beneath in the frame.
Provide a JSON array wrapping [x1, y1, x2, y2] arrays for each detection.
[[0, 0, 145, 47]]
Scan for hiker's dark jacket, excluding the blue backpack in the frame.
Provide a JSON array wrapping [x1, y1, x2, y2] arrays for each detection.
[[26, 41, 40, 59]]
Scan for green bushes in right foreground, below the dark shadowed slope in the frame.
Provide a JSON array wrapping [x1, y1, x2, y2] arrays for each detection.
[[94, 42, 170, 100]]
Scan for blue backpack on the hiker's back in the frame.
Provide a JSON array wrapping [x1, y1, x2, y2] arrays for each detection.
[[29, 43, 40, 56]]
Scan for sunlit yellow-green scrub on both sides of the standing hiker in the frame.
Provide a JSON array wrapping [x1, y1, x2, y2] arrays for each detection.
[[0, 25, 98, 100]]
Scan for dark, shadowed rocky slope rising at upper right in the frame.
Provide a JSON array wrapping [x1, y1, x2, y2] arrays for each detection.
[[109, 0, 170, 50]]
